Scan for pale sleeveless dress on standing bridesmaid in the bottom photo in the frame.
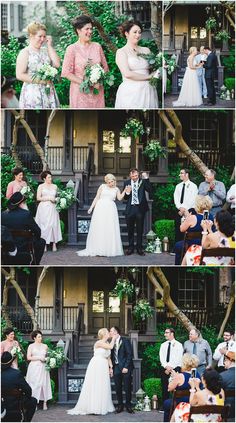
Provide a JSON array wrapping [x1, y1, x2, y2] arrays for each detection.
[[25, 344, 52, 402]]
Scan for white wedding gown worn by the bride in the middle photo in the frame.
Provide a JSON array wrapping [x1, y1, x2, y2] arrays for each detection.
[[77, 184, 124, 257]]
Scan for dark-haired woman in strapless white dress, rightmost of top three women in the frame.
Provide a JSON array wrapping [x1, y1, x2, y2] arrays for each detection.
[[115, 21, 158, 109]]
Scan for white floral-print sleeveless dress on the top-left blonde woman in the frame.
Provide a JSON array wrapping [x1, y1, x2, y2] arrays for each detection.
[[19, 47, 60, 109]]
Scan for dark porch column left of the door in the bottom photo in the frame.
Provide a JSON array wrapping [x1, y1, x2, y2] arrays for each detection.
[[53, 267, 64, 334]]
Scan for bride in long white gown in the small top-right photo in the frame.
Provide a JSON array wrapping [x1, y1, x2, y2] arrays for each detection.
[[173, 47, 203, 107]]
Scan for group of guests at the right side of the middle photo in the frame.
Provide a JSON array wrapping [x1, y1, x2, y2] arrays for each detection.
[[173, 169, 236, 266]]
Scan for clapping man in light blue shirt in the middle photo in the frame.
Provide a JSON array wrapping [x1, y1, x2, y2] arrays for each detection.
[[198, 169, 226, 217]]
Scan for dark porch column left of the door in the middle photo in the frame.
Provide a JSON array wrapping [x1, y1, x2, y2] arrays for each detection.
[[62, 111, 74, 175]]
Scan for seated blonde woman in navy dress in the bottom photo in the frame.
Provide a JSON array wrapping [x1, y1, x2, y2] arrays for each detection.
[[163, 353, 200, 422]]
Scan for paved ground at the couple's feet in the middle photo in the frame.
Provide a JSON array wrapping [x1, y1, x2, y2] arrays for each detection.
[[40, 246, 175, 266]]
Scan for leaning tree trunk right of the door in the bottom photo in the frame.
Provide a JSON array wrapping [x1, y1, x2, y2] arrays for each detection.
[[147, 267, 196, 332]]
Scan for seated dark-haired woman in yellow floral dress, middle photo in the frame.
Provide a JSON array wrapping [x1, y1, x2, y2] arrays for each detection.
[[182, 210, 235, 266]]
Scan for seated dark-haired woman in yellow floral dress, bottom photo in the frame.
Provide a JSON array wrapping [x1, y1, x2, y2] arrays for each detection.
[[170, 369, 225, 422]]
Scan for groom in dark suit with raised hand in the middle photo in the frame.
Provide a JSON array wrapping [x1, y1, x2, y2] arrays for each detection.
[[124, 169, 151, 256]]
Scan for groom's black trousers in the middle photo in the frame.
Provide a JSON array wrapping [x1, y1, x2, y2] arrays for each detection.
[[126, 205, 145, 250]]
